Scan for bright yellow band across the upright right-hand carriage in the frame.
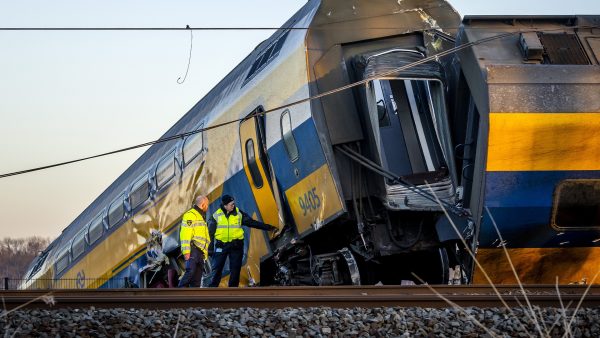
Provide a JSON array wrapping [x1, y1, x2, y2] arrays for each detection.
[[487, 113, 600, 171]]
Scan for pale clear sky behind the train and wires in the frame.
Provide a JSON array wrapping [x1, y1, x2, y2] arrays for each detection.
[[0, 0, 600, 238]]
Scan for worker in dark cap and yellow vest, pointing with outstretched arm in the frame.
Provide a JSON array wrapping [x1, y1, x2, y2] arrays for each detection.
[[208, 195, 277, 287]]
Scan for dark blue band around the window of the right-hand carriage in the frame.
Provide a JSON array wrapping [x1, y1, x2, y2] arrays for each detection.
[[479, 171, 600, 248]]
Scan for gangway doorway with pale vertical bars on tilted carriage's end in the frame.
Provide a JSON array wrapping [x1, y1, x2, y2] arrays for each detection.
[[370, 79, 448, 184]]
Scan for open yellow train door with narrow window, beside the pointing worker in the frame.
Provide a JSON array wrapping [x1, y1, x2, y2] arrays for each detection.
[[240, 108, 283, 279]]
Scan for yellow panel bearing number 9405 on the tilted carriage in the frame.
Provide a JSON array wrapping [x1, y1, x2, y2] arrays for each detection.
[[285, 164, 342, 234]]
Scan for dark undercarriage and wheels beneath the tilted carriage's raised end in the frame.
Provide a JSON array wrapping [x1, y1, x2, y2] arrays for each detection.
[[268, 205, 471, 286]]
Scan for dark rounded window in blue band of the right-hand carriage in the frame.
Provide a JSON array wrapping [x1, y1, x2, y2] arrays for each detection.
[[552, 179, 600, 230]]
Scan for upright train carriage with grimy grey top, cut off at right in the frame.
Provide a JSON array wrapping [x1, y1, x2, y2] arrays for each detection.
[[459, 16, 600, 284]]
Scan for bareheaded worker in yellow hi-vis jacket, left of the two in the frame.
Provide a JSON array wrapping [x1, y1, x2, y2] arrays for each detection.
[[178, 196, 210, 288]]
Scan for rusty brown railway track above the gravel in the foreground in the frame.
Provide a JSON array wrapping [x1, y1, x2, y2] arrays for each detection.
[[0, 285, 600, 310]]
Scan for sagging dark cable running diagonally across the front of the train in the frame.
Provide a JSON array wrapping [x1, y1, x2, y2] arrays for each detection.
[[0, 25, 600, 179]]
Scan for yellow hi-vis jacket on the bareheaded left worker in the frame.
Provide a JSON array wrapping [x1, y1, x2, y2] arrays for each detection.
[[179, 208, 210, 259]]
